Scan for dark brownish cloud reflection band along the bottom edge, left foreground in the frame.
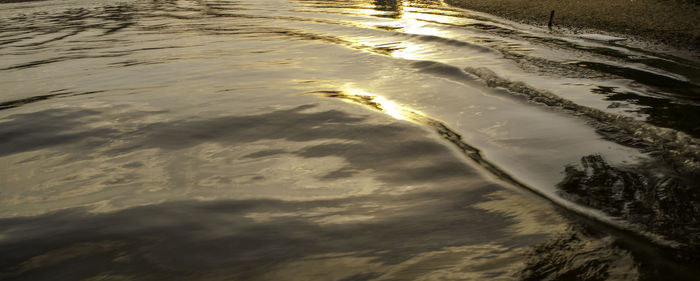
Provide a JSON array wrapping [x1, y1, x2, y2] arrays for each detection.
[[0, 185, 536, 280]]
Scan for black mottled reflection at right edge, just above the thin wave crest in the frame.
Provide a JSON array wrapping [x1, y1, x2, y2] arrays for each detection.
[[558, 155, 700, 255]]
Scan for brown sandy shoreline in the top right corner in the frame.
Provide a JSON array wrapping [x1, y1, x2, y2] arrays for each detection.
[[445, 0, 700, 50]]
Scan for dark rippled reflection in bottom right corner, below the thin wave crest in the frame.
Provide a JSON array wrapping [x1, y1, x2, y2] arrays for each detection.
[[518, 225, 700, 281]]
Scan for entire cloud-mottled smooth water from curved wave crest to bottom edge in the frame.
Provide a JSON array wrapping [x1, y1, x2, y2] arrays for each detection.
[[0, 100, 644, 280]]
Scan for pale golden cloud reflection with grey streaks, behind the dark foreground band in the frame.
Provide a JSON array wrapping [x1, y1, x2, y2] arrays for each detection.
[[0, 101, 475, 215]]
